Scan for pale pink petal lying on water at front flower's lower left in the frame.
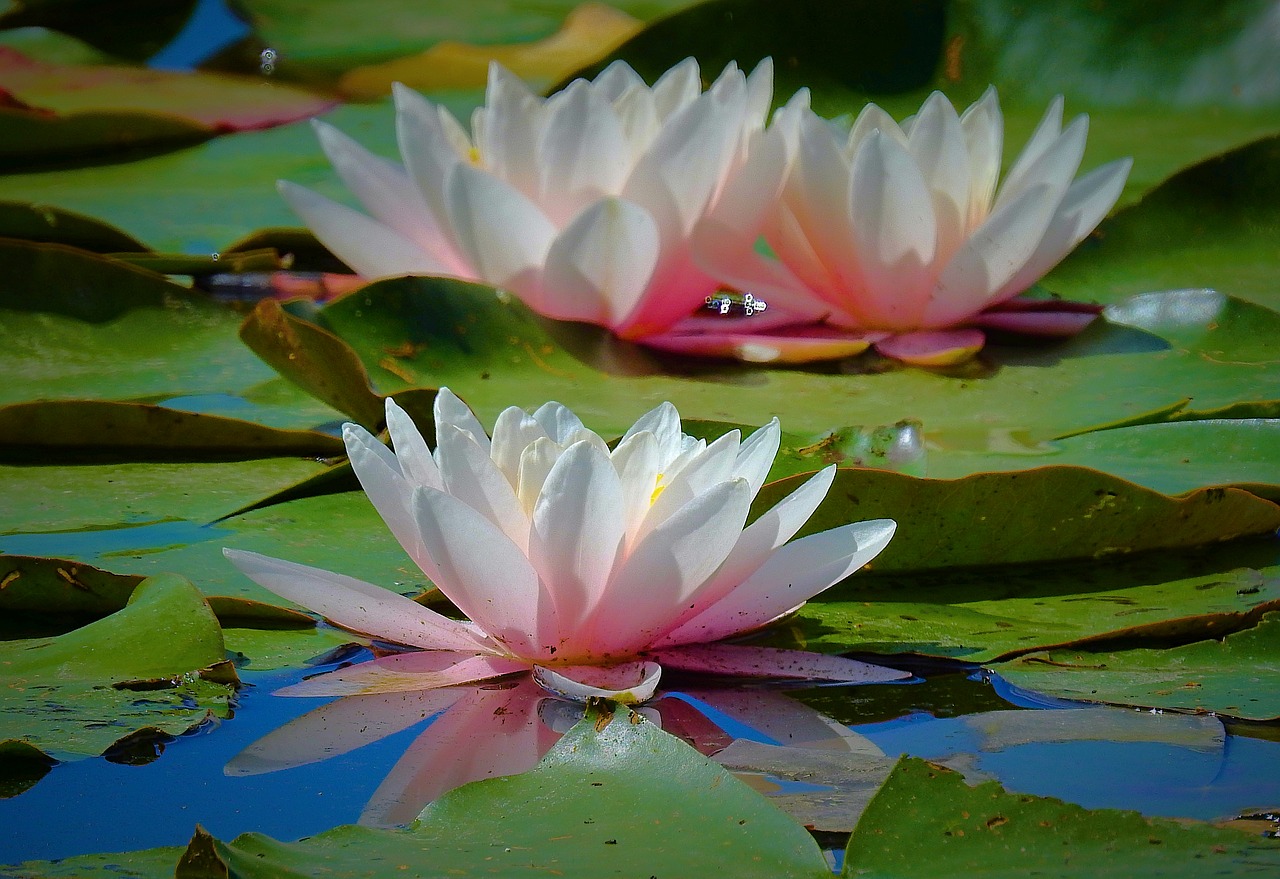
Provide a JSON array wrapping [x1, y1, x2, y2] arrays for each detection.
[[275, 650, 529, 696]]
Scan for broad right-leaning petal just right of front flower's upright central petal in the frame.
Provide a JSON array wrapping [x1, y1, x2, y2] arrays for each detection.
[[589, 480, 751, 654]]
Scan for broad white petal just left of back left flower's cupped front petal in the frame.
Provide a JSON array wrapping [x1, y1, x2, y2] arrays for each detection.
[[444, 164, 556, 294]]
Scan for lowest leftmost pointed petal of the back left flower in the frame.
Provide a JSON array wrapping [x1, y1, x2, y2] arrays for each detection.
[[276, 180, 453, 278]]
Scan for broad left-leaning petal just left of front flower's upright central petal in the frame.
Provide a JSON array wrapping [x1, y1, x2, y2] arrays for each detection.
[[413, 487, 559, 656]]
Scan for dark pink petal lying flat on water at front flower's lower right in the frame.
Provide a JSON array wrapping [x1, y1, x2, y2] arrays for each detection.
[[646, 644, 911, 683]]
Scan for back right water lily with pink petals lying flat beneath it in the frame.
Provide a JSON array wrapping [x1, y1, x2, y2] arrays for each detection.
[[659, 88, 1132, 366]]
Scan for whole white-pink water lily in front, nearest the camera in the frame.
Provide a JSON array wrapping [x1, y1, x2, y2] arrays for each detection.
[[225, 389, 902, 701]]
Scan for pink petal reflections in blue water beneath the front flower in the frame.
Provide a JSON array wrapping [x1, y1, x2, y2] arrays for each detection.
[[225, 676, 890, 827]]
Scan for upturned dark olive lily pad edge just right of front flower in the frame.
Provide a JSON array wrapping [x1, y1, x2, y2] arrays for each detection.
[[753, 467, 1280, 572]]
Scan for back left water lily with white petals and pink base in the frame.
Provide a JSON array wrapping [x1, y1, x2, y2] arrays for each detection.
[[280, 59, 785, 339]]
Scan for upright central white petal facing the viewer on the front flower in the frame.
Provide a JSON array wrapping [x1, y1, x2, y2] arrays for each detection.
[[529, 443, 625, 632]]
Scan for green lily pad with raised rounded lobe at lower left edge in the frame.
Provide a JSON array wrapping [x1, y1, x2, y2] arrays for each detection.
[[0, 574, 234, 759]]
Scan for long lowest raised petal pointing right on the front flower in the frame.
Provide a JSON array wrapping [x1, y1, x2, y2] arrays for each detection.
[[660, 519, 897, 647]]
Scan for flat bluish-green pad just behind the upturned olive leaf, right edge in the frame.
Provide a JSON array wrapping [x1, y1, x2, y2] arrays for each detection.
[[928, 418, 1280, 502]]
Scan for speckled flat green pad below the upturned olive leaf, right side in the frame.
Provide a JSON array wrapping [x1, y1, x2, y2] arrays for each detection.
[[764, 541, 1280, 663]]
